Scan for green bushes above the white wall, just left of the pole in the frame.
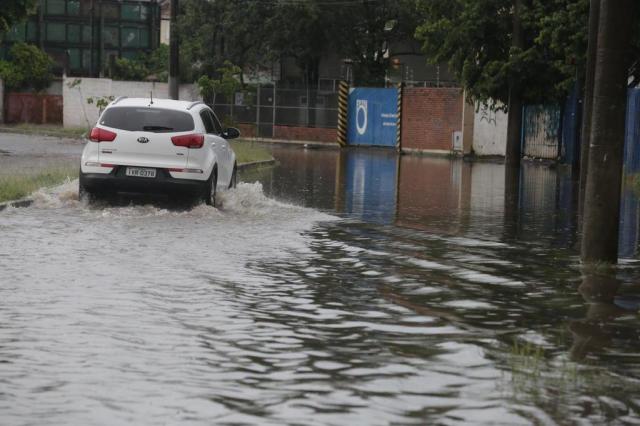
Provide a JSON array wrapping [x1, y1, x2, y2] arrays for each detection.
[[111, 45, 169, 81]]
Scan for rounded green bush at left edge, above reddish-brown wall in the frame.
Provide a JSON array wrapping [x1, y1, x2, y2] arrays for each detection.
[[0, 43, 53, 92]]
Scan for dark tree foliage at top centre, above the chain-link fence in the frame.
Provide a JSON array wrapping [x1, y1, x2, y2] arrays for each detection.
[[178, 0, 417, 84]]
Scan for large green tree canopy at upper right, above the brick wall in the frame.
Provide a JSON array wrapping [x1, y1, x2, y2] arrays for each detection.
[[416, 0, 588, 104]]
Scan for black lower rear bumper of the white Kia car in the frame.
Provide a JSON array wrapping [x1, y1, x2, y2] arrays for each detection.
[[80, 166, 207, 195]]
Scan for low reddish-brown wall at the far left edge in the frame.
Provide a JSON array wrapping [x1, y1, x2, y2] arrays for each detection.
[[6, 93, 62, 124]]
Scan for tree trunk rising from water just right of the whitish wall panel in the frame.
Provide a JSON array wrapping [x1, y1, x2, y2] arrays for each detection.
[[505, 0, 524, 168]]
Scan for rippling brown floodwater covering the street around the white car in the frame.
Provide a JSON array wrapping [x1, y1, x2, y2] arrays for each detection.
[[0, 148, 640, 425]]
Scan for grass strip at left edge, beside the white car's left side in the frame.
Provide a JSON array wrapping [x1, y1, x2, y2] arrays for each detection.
[[0, 168, 78, 202]]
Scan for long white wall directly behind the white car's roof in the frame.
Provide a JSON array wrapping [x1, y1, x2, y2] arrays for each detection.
[[62, 77, 201, 127]]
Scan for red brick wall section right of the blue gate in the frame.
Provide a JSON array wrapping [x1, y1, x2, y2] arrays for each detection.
[[400, 87, 463, 151]]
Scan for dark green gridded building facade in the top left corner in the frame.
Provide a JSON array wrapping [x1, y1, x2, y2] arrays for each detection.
[[0, 0, 160, 77]]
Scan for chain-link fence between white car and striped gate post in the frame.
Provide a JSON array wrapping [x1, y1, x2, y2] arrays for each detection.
[[211, 86, 338, 138]]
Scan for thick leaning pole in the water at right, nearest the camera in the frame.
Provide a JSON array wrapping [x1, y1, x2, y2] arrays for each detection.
[[581, 0, 637, 263]]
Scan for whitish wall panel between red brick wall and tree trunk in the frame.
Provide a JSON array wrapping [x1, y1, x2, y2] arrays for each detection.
[[473, 106, 508, 156]]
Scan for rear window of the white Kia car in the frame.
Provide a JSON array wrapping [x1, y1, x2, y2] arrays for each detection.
[[100, 107, 194, 132]]
